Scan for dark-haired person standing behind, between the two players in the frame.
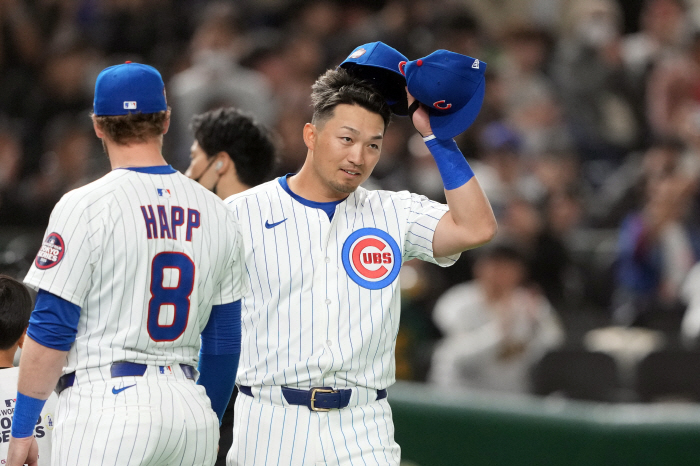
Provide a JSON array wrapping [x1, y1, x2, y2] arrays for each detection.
[[185, 107, 275, 466]]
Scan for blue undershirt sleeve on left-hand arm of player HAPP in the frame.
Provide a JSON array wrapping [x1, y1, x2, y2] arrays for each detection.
[[27, 290, 80, 351]]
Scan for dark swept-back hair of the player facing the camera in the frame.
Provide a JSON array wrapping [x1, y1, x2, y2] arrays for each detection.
[[311, 68, 391, 129]]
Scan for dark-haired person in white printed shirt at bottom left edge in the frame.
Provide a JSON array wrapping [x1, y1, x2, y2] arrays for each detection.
[[0, 275, 56, 466]]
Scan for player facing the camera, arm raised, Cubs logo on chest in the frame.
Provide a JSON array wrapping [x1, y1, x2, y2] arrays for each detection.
[[225, 51, 496, 466]]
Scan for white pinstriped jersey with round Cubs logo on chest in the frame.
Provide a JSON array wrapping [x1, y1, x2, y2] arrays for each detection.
[[225, 180, 459, 389]]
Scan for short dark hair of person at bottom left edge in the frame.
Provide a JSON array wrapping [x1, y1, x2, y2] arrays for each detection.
[[0, 275, 32, 350]]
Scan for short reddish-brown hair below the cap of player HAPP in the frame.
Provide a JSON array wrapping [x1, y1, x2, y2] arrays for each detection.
[[93, 110, 170, 146]]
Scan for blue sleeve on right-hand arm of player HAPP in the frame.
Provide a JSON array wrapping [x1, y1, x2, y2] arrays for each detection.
[[197, 300, 241, 424]]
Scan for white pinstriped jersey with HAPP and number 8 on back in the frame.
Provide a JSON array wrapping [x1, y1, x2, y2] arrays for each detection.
[[25, 166, 246, 372]]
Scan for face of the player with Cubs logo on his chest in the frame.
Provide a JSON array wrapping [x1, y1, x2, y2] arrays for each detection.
[[313, 104, 384, 194]]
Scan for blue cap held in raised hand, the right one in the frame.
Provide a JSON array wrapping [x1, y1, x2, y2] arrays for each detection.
[[404, 50, 486, 139]]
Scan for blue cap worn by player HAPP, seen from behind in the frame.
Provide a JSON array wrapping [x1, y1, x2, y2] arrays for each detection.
[[93, 61, 168, 116]]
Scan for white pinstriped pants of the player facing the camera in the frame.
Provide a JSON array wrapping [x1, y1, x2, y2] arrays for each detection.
[[226, 386, 401, 466]]
